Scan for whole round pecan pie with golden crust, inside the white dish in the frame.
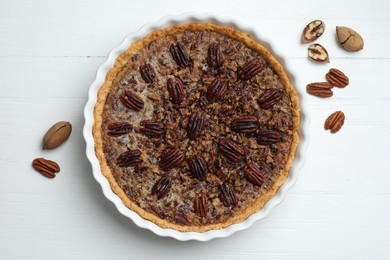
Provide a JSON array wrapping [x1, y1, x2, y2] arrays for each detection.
[[93, 23, 300, 232]]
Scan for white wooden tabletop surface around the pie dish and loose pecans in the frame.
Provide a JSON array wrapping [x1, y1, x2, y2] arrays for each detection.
[[0, 0, 390, 260]]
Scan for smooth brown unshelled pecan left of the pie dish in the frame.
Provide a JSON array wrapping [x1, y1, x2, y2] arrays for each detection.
[[42, 121, 72, 149]]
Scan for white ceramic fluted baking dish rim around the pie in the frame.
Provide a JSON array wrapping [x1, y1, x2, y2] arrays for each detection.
[[83, 13, 309, 241]]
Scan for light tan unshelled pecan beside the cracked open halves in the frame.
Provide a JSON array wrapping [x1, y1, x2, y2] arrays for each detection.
[[336, 26, 364, 51]]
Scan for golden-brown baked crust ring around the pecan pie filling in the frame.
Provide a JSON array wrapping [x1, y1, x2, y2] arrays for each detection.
[[93, 23, 300, 232]]
